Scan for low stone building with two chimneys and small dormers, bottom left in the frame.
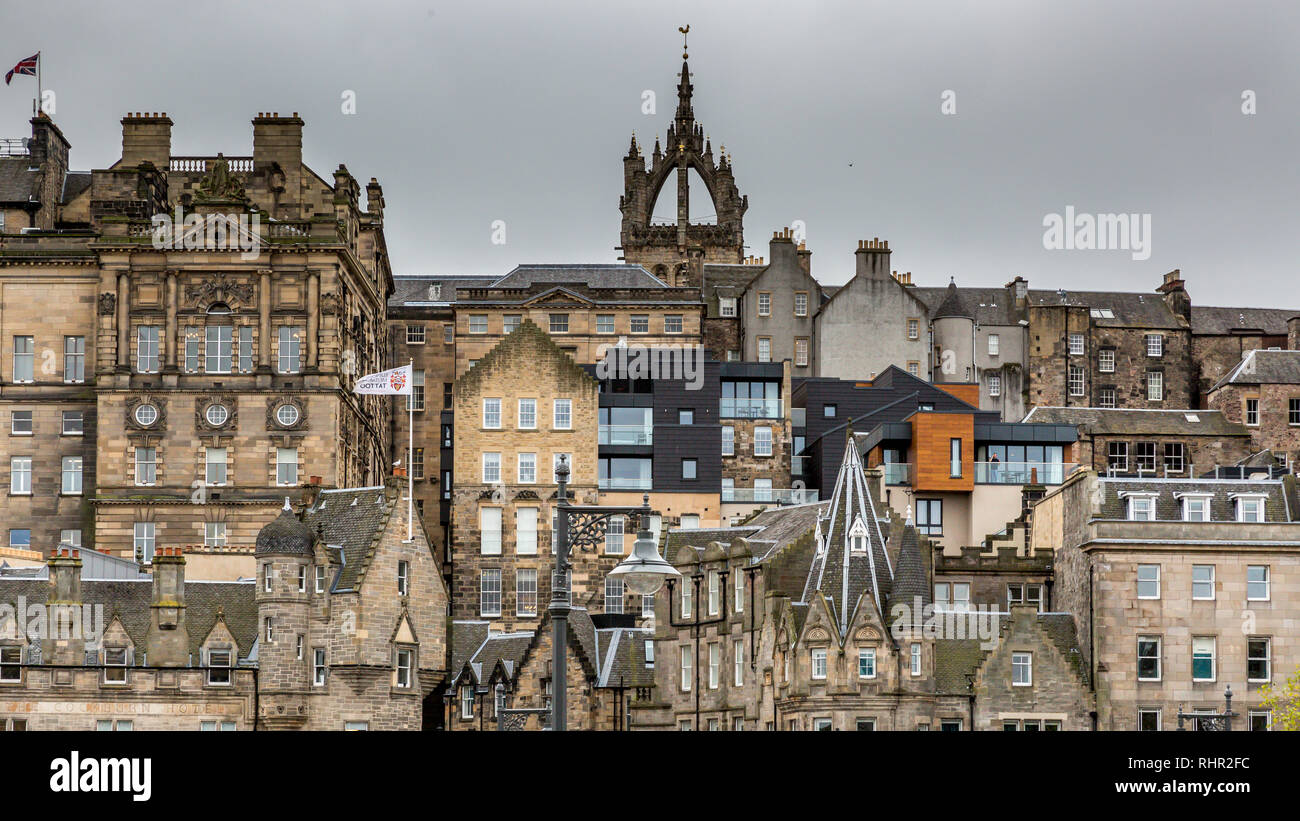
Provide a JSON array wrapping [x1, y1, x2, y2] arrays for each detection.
[[0, 547, 257, 731]]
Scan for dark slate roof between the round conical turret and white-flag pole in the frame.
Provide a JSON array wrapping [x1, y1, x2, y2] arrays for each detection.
[[303, 487, 397, 592]]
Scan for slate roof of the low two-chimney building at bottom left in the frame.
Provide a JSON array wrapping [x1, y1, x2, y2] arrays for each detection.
[[0, 577, 257, 663]]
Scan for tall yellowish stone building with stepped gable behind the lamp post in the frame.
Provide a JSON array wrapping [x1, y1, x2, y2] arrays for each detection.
[[451, 320, 611, 633]]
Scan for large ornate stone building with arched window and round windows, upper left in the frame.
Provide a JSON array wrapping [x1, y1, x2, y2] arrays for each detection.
[[0, 113, 393, 561]]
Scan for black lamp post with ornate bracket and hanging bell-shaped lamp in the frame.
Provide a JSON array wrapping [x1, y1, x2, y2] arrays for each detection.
[[547, 456, 680, 730]]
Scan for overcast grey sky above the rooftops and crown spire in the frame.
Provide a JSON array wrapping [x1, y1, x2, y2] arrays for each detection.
[[0, 0, 1300, 308]]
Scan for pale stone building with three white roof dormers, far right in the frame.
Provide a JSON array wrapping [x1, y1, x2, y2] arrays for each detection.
[[1032, 470, 1300, 730]]
